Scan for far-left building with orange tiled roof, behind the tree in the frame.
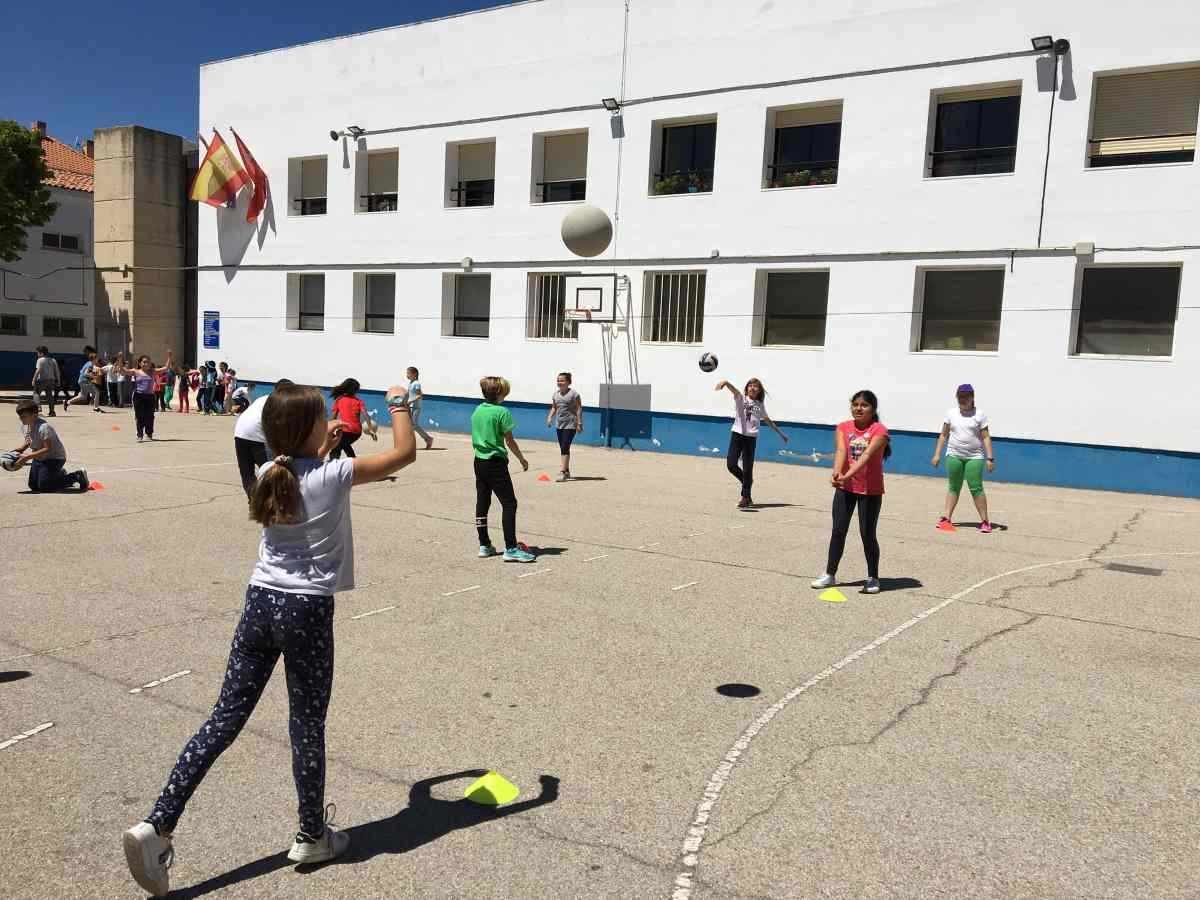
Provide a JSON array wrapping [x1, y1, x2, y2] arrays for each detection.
[[0, 122, 96, 385]]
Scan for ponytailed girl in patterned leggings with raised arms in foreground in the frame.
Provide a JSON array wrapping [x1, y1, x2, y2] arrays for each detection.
[[124, 384, 416, 896]]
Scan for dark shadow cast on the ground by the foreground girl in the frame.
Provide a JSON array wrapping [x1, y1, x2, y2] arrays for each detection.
[[170, 769, 558, 898]]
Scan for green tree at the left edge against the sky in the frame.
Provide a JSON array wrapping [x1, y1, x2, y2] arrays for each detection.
[[0, 121, 59, 263]]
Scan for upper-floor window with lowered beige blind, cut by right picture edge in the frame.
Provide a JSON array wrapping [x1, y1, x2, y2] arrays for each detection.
[[1087, 66, 1200, 167]]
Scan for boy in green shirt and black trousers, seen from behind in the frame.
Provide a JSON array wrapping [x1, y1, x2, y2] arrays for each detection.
[[470, 376, 536, 563]]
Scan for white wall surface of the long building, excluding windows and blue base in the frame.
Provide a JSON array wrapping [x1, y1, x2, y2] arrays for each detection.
[[199, 0, 1200, 451]]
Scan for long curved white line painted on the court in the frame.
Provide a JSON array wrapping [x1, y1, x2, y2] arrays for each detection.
[[671, 550, 1200, 900]]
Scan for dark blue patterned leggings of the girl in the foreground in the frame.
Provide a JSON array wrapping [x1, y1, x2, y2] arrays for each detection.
[[146, 584, 334, 836]]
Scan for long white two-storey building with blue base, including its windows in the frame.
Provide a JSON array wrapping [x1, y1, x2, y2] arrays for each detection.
[[199, 0, 1200, 496]]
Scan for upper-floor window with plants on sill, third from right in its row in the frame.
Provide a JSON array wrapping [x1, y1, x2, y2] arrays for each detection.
[[767, 103, 841, 187]]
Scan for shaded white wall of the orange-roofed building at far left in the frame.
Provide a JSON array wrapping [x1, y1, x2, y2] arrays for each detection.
[[0, 187, 96, 360]]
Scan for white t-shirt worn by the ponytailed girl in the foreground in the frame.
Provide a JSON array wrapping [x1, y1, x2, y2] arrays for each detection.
[[250, 458, 354, 595]]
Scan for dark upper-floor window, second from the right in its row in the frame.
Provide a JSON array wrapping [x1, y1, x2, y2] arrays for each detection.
[[929, 86, 1021, 178]]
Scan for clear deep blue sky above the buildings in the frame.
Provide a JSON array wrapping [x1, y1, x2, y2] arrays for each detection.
[[0, 0, 504, 144]]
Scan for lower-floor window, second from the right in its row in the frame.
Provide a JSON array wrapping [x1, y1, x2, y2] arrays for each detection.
[[917, 269, 1004, 352]]
